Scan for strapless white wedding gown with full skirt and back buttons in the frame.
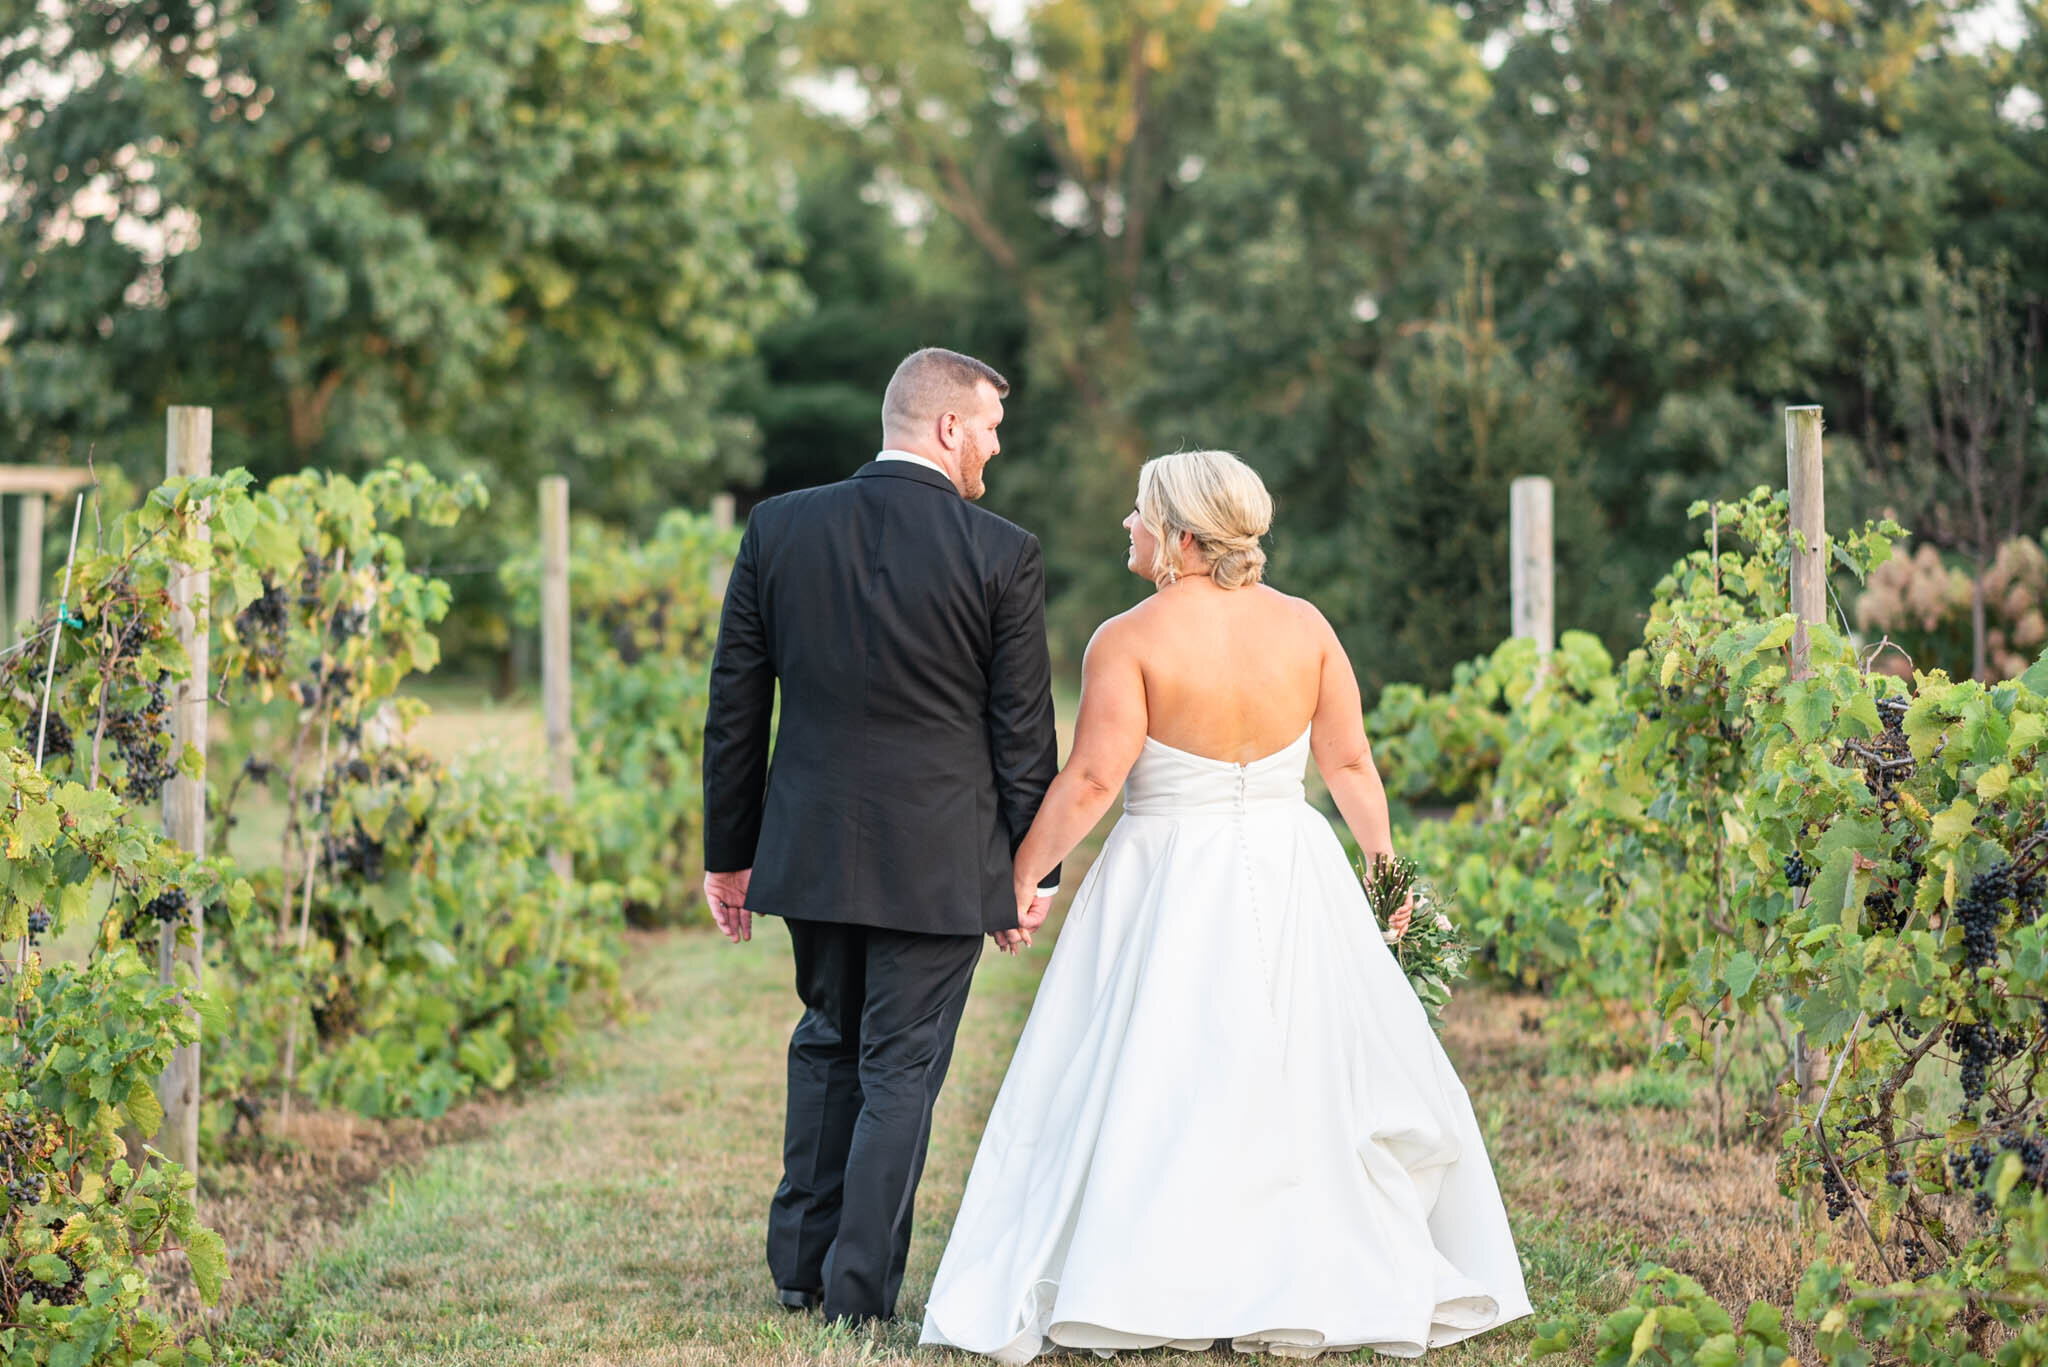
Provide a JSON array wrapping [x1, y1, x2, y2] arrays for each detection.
[[924, 734, 1530, 1363]]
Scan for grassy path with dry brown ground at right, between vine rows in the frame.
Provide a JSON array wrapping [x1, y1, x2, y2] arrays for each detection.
[[216, 889, 1835, 1367]]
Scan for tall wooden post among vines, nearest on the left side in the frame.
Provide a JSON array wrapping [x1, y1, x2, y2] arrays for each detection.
[[156, 408, 213, 1172]]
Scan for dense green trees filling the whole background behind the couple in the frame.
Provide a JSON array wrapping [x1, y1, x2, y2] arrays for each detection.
[[0, 0, 2048, 687]]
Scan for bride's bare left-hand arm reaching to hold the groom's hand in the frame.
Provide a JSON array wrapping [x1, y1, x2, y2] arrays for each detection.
[[1016, 617, 1147, 909]]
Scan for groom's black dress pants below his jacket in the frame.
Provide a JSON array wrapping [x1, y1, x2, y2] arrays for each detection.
[[768, 920, 981, 1320]]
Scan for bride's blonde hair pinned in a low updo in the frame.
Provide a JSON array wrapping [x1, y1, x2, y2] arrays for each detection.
[[1139, 451, 1274, 588]]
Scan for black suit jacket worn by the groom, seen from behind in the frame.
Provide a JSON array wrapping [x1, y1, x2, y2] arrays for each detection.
[[705, 461, 1059, 935]]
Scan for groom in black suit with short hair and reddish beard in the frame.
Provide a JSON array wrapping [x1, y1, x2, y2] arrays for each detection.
[[705, 346, 1059, 1320]]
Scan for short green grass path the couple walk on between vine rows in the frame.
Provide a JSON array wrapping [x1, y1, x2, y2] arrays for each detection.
[[216, 918, 1642, 1367]]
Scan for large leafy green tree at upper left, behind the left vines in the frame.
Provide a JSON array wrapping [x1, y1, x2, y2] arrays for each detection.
[[0, 0, 797, 516]]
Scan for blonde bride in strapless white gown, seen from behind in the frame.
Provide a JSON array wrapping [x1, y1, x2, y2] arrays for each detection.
[[924, 451, 1530, 1363]]
